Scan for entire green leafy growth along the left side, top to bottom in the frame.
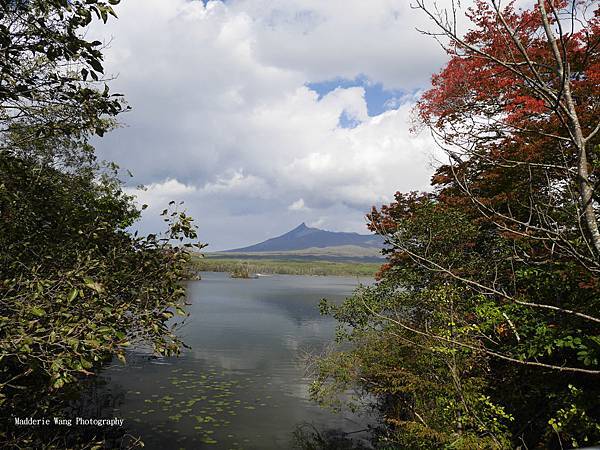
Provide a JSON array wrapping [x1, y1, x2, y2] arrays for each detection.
[[0, 0, 204, 448]]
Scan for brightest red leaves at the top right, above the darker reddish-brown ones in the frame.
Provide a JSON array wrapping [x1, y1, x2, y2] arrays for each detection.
[[418, 0, 600, 141]]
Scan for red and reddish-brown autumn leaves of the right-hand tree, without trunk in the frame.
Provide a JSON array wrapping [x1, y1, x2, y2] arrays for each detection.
[[368, 0, 600, 273]]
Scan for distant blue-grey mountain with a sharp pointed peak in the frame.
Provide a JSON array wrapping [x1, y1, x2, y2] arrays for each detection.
[[227, 223, 383, 253]]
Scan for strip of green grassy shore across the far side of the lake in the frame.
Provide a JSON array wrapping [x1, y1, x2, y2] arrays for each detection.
[[192, 257, 381, 277]]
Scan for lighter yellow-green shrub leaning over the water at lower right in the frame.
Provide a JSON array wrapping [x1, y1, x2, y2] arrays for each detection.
[[311, 279, 513, 449]]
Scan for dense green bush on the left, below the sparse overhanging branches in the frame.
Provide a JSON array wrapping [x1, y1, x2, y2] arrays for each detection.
[[0, 145, 202, 446]]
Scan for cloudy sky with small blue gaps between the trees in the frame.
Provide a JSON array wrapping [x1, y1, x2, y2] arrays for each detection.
[[88, 0, 458, 251]]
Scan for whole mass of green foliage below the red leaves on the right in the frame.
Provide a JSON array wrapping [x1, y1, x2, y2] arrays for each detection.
[[311, 195, 600, 448]]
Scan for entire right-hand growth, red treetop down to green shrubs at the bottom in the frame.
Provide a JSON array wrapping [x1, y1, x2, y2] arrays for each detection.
[[314, 0, 600, 448]]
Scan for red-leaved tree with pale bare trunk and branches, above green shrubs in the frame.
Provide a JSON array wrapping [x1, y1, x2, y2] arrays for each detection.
[[418, 0, 600, 272]]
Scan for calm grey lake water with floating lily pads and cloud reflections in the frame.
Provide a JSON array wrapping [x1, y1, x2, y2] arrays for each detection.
[[94, 273, 368, 450]]
